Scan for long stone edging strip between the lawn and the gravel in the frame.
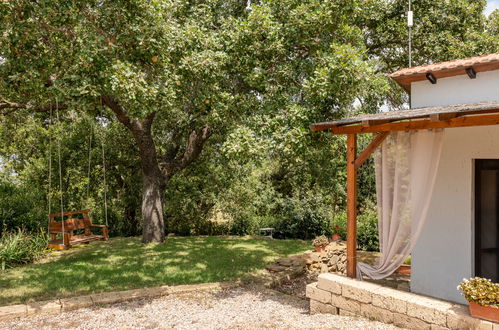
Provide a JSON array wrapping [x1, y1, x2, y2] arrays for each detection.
[[0, 282, 239, 322]]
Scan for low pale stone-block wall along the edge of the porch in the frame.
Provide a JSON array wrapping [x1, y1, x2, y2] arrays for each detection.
[[307, 274, 499, 330]]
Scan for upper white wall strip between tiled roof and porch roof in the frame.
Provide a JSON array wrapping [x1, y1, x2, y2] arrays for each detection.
[[411, 70, 499, 108]]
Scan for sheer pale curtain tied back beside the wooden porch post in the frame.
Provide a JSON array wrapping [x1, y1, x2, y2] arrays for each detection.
[[357, 129, 443, 279]]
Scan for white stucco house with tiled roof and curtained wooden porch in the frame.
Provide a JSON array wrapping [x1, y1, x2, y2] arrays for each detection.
[[311, 53, 499, 303]]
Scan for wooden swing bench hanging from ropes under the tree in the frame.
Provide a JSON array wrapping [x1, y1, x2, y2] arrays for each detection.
[[48, 210, 109, 250]]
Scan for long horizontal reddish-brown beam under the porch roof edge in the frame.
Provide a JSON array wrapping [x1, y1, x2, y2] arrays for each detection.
[[329, 114, 499, 134]]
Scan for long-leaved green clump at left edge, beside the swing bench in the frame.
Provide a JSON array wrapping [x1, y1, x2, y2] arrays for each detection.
[[0, 229, 48, 269]]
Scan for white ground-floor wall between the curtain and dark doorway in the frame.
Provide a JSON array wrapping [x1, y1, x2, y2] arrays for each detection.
[[411, 125, 499, 303]]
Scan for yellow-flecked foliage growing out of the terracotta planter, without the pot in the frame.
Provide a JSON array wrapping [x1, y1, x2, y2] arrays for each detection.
[[457, 277, 499, 307]]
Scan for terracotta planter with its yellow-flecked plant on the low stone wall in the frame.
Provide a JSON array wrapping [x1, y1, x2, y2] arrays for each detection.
[[457, 277, 499, 322]]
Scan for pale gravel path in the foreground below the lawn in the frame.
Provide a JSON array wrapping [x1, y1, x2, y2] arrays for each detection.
[[0, 288, 399, 330]]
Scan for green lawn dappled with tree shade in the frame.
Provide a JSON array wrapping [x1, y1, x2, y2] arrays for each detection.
[[0, 237, 310, 306]]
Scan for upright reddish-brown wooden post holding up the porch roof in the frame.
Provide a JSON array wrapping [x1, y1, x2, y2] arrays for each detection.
[[347, 134, 357, 278]]
